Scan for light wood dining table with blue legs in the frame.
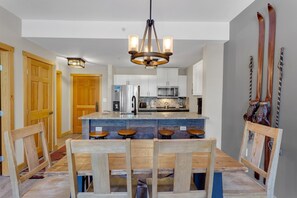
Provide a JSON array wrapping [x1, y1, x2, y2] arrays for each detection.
[[45, 139, 247, 198]]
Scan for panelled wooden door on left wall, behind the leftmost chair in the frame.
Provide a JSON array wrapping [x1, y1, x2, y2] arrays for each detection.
[[24, 53, 54, 151]]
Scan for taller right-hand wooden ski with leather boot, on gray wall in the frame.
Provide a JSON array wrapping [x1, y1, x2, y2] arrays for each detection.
[[253, 4, 276, 178]]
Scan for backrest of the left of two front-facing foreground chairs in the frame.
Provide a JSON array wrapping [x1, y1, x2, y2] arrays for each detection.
[[66, 139, 132, 198]]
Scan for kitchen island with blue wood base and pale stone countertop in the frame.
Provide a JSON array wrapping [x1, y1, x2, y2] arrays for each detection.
[[80, 112, 207, 139]]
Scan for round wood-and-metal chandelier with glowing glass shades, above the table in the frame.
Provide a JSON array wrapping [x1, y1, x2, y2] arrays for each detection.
[[128, 0, 173, 68]]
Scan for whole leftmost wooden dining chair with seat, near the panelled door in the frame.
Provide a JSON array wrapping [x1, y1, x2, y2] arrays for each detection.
[[4, 123, 70, 198]]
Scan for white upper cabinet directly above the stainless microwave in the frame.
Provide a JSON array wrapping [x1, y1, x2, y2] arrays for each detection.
[[157, 68, 178, 86]]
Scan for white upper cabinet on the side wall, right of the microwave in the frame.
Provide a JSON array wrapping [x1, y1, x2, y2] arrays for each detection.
[[193, 60, 203, 96]]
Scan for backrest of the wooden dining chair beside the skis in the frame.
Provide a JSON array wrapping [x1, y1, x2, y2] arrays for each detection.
[[239, 121, 283, 196]]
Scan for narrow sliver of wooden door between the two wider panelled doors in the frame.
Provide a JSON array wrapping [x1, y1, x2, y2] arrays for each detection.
[[56, 71, 62, 138]]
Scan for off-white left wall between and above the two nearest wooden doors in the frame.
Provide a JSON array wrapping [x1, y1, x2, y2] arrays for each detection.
[[0, 7, 55, 163]]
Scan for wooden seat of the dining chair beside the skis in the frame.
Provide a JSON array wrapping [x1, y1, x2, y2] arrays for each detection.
[[223, 172, 267, 197]]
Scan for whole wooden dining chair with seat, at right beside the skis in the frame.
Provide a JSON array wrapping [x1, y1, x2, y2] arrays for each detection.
[[223, 121, 283, 198]]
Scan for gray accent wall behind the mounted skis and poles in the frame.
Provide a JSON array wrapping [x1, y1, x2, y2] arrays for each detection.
[[222, 0, 297, 198]]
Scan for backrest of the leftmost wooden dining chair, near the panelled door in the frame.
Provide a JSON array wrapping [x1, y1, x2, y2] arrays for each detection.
[[4, 123, 51, 198]]
